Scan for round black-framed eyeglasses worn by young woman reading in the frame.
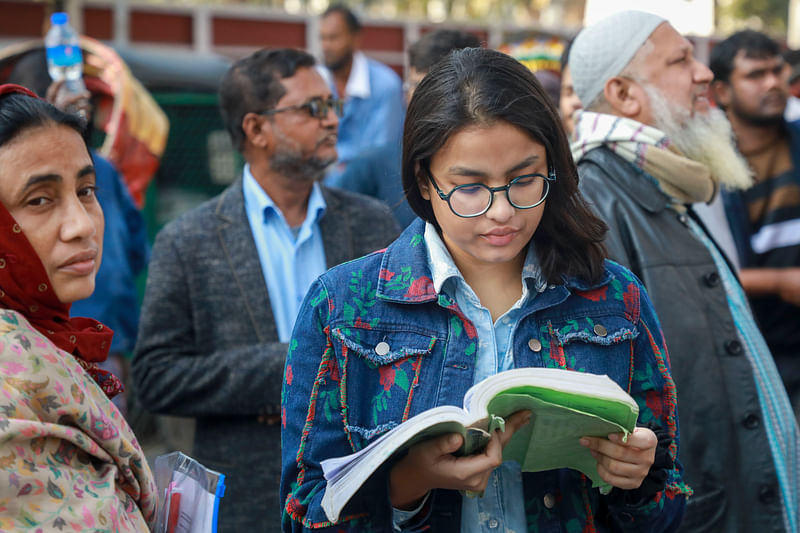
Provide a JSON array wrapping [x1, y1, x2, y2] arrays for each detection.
[[425, 168, 556, 218]]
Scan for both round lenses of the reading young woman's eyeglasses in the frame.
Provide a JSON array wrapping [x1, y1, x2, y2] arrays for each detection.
[[450, 175, 549, 216]]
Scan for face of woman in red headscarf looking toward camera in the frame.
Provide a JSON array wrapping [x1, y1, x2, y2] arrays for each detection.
[[0, 125, 103, 303]]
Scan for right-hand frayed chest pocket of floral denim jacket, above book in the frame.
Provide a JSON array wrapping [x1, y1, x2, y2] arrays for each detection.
[[548, 315, 639, 388]]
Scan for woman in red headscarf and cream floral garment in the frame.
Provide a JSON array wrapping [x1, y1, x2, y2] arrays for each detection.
[[0, 85, 156, 531]]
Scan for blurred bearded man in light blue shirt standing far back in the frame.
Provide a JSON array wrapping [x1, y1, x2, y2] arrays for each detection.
[[318, 4, 405, 182]]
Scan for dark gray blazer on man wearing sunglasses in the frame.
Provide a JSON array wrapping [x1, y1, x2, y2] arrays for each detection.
[[133, 178, 400, 533]]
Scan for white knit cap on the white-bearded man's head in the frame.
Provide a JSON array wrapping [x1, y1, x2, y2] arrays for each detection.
[[569, 11, 666, 106]]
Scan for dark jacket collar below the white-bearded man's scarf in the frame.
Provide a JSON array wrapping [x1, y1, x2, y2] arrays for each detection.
[[578, 146, 671, 213]]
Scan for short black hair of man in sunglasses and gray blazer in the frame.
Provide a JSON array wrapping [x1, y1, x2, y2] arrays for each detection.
[[219, 48, 315, 151]]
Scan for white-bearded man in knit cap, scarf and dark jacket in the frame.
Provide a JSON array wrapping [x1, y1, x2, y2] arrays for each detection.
[[569, 12, 800, 533]]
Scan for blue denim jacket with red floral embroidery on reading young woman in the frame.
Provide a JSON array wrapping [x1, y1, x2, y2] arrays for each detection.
[[281, 220, 691, 533]]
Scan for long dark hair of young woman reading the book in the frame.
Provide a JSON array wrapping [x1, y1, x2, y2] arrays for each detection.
[[403, 48, 608, 283]]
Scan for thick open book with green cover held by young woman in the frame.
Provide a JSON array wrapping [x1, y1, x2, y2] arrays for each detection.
[[322, 368, 639, 522]]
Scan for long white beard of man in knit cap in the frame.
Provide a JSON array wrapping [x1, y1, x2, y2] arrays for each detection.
[[644, 85, 753, 189]]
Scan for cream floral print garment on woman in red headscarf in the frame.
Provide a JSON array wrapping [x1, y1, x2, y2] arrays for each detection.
[[0, 309, 156, 532]]
